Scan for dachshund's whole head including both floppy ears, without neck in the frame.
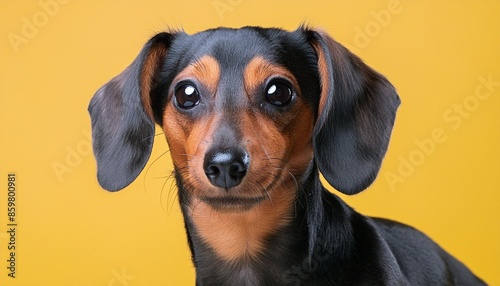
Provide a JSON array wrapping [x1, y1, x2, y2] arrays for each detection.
[[89, 27, 399, 210]]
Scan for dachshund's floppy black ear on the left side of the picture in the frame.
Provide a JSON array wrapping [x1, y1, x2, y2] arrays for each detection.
[[89, 33, 175, 191]]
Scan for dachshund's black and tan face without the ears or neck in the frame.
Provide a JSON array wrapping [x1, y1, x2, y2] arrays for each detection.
[[158, 29, 320, 211]]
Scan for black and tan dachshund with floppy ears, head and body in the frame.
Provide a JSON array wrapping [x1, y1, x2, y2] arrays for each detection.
[[89, 26, 485, 286]]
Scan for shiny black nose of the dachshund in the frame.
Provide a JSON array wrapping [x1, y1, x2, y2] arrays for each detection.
[[203, 148, 250, 189]]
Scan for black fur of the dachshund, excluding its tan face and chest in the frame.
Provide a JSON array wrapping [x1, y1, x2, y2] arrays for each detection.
[[89, 27, 484, 286]]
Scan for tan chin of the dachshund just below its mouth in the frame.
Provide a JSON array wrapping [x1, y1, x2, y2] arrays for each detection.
[[200, 196, 266, 212]]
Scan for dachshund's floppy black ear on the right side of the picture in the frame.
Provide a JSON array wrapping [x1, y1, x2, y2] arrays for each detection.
[[309, 31, 400, 195]]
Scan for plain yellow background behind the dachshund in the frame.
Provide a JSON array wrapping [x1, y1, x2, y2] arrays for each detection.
[[0, 0, 500, 286]]
